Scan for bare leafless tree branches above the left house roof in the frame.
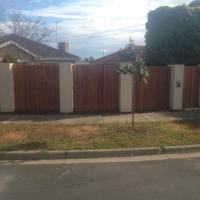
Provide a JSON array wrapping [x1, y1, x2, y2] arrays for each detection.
[[0, 12, 53, 42]]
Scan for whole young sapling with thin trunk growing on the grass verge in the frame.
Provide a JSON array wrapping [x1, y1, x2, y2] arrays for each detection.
[[117, 40, 149, 128]]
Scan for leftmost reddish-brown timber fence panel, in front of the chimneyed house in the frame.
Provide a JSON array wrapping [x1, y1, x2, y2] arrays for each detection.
[[13, 64, 60, 113]]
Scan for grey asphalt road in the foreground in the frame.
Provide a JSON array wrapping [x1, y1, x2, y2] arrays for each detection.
[[0, 154, 200, 200]]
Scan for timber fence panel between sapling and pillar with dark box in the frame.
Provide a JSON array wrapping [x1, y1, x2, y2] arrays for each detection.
[[135, 66, 170, 112]]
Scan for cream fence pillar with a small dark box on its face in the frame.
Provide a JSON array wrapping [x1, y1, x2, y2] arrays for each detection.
[[170, 65, 184, 110]]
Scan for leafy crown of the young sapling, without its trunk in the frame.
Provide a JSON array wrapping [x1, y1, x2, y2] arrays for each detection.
[[117, 40, 149, 83]]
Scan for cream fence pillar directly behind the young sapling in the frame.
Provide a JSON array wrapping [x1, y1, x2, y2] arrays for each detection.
[[119, 74, 133, 113]]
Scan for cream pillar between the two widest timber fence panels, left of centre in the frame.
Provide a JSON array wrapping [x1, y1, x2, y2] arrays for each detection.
[[59, 63, 73, 113]]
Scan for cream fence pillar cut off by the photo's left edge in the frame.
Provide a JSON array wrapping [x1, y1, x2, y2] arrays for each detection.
[[0, 63, 15, 112]]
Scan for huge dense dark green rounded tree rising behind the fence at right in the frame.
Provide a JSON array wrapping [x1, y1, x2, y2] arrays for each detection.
[[145, 6, 200, 65]]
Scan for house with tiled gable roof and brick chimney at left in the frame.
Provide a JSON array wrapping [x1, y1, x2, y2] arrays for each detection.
[[0, 34, 80, 63]]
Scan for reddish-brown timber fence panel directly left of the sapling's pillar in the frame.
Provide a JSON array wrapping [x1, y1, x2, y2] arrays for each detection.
[[73, 64, 119, 113]]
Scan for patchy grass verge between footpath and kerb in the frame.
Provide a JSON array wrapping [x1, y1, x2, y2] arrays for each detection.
[[0, 120, 200, 151]]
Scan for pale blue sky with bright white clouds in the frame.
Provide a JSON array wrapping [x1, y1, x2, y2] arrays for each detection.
[[0, 0, 191, 58]]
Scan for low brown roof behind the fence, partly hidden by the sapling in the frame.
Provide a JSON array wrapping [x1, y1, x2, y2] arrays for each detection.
[[93, 46, 144, 63]]
